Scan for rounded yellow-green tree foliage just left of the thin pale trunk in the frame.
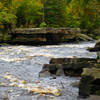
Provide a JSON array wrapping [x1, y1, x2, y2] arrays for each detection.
[[16, 0, 43, 27]]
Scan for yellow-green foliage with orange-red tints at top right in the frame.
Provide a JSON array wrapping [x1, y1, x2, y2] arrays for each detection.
[[66, 0, 100, 29]]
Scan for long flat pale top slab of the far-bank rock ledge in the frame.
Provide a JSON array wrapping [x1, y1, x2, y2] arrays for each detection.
[[15, 28, 81, 34]]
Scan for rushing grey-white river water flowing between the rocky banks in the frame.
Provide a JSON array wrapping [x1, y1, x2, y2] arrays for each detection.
[[0, 42, 97, 100]]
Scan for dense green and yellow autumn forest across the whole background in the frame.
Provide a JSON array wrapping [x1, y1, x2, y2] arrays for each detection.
[[0, 0, 100, 29]]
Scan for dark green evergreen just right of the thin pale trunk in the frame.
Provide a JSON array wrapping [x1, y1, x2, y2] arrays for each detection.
[[44, 0, 67, 27]]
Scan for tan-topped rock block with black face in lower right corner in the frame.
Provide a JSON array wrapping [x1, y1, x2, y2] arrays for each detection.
[[79, 68, 100, 97]]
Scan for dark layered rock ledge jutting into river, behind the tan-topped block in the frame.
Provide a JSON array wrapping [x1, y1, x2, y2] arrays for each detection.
[[40, 58, 97, 76]]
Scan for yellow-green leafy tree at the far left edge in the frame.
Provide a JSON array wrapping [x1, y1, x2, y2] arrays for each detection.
[[0, 2, 16, 41]]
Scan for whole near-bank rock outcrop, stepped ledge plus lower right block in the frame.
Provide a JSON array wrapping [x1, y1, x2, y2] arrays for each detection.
[[39, 58, 100, 98]]
